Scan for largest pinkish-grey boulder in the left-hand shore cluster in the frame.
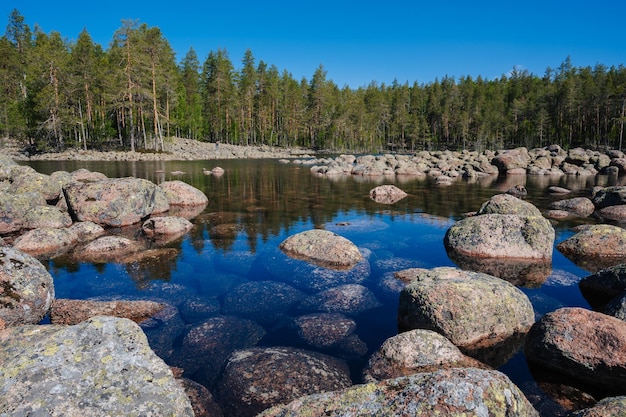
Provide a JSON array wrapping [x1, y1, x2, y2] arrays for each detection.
[[63, 178, 168, 227]]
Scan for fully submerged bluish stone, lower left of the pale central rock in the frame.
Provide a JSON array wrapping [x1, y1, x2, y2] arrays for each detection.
[[223, 281, 305, 325]]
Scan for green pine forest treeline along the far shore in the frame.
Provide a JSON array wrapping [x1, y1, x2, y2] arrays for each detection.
[[0, 10, 626, 152]]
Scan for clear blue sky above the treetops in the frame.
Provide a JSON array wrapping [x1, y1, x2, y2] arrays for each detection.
[[0, 0, 626, 88]]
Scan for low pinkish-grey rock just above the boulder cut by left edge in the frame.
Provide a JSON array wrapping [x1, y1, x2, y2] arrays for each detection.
[[13, 228, 78, 259]]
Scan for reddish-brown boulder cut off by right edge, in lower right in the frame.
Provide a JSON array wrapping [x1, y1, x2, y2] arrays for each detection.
[[524, 308, 626, 394]]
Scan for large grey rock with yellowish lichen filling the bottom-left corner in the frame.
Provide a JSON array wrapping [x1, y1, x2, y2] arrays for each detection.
[[0, 317, 193, 417]]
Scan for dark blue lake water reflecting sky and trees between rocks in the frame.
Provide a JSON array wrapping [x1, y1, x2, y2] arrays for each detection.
[[28, 160, 622, 412]]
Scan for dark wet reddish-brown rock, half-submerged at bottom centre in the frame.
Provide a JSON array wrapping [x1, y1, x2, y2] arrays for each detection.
[[218, 347, 352, 417]]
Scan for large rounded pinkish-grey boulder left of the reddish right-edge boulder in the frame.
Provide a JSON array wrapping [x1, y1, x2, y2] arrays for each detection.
[[398, 267, 535, 348]]
